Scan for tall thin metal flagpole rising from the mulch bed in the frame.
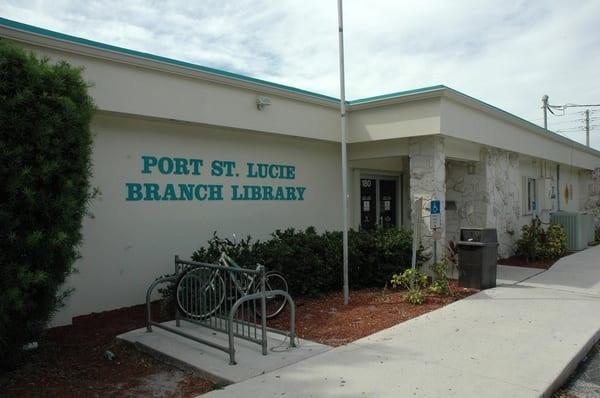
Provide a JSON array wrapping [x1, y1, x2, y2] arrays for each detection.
[[338, 0, 350, 305]]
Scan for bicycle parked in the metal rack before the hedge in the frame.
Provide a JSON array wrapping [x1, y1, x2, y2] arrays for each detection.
[[175, 252, 288, 319]]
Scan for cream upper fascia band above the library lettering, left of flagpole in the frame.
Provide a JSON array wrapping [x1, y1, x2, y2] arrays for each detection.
[[9, 43, 340, 141]]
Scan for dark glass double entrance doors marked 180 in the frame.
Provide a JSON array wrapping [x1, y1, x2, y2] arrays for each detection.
[[360, 177, 398, 229]]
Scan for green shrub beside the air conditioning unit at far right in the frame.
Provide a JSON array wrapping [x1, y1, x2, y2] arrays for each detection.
[[516, 219, 567, 260]]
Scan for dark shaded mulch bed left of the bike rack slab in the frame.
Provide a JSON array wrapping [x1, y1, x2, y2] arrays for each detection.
[[0, 303, 213, 397]]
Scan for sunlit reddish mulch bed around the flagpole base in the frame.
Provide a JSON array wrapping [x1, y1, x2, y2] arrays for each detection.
[[269, 280, 478, 346]]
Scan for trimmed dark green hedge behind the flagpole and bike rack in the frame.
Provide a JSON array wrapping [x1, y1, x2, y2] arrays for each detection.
[[192, 227, 423, 296]]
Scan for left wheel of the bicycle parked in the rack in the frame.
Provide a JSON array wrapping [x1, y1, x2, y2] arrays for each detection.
[[175, 268, 225, 319]]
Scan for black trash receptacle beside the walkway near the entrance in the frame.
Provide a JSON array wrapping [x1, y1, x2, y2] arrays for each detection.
[[458, 228, 498, 289]]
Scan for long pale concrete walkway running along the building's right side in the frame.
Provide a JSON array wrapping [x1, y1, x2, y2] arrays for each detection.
[[206, 247, 600, 397]]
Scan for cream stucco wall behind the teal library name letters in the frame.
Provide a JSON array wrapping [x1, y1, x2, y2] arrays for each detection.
[[54, 114, 341, 325]]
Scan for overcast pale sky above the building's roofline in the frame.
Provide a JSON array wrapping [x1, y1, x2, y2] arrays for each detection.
[[0, 0, 600, 148]]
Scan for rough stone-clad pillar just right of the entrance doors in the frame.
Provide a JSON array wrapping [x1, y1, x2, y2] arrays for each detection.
[[409, 136, 446, 262]]
